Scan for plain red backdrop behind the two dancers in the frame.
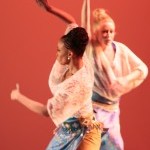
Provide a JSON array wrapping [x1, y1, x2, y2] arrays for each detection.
[[0, 0, 150, 150]]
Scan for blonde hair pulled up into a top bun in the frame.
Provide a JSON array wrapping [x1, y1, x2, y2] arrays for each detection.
[[93, 8, 115, 32]]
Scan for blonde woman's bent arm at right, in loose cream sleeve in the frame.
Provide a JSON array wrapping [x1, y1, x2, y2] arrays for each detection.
[[109, 46, 148, 95]]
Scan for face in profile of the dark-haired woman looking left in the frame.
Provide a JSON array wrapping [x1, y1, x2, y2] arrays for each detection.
[[57, 41, 69, 65]]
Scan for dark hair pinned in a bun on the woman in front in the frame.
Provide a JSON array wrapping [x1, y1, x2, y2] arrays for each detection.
[[61, 27, 89, 57]]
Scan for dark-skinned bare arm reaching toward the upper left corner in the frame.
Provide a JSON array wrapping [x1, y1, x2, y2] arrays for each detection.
[[36, 0, 76, 24]]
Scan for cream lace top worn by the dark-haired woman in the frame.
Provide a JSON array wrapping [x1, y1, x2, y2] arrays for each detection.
[[47, 55, 94, 126]]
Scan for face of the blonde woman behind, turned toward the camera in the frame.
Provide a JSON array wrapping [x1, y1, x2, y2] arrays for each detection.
[[96, 21, 115, 45]]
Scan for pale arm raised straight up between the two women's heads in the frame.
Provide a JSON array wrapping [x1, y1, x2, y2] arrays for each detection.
[[81, 0, 91, 38]]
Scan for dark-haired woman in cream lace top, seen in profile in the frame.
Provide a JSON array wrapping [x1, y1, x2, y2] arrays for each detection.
[[11, 27, 102, 150]]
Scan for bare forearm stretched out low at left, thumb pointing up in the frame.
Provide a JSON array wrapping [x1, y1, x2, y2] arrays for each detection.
[[11, 84, 49, 117]]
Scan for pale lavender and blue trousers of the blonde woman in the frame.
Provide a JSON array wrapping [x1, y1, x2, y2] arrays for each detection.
[[94, 107, 124, 150]]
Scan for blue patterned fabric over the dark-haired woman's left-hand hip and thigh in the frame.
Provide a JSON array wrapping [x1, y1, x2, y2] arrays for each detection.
[[46, 118, 85, 150]]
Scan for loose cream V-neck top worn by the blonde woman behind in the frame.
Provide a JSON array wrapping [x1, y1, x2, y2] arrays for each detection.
[[87, 41, 148, 108]]
